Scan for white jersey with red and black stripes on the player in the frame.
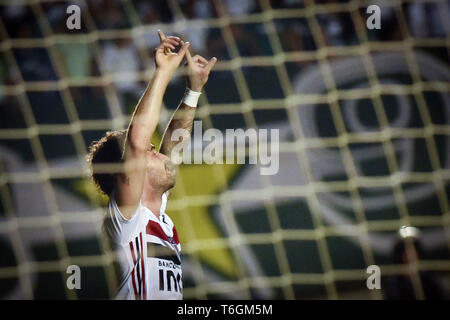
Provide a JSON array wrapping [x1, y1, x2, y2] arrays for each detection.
[[103, 194, 183, 300]]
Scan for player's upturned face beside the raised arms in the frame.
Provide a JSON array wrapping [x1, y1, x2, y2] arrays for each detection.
[[146, 144, 175, 190]]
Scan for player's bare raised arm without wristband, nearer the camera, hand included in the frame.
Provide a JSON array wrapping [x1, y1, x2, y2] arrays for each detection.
[[115, 31, 189, 219]]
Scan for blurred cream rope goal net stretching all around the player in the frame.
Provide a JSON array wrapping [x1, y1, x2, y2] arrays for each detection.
[[0, 0, 450, 299]]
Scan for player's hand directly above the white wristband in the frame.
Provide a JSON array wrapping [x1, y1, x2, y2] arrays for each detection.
[[185, 50, 217, 92]]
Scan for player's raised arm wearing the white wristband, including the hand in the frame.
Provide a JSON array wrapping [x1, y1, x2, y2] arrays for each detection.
[[160, 32, 217, 160]]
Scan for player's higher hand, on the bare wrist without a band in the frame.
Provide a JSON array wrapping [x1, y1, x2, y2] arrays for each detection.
[[155, 30, 190, 73]]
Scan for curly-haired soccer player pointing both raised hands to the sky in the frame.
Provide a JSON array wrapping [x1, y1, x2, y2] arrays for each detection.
[[88, 31, 217, 299]]
